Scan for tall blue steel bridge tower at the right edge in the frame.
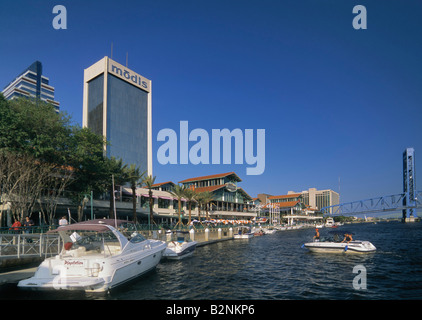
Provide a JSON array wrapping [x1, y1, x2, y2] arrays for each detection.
[[402, 148, 416, 222]]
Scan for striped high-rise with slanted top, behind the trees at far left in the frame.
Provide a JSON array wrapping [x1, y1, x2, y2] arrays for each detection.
[[2, 61, 60, 112]]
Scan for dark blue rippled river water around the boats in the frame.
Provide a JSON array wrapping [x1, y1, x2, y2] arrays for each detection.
[[0, 222, 422, 300]]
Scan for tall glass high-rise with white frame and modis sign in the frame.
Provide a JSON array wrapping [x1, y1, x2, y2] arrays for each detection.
[[83, 57, 152, 175]]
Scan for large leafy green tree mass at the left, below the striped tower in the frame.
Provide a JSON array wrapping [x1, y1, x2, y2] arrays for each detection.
[[0, 95, 78, 222]]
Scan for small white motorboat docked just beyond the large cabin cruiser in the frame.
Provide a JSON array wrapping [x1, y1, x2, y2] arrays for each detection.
[[163, 231, 197, 260]]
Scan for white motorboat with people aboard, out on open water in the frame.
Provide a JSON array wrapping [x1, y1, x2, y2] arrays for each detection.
[[303, 231, 377, 253]]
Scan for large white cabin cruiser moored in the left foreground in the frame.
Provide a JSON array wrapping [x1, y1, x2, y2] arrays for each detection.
[[18, 219, 166, 292]]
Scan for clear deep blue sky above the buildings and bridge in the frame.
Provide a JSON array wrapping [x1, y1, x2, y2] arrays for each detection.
[[0, 0, 422, 202]]
